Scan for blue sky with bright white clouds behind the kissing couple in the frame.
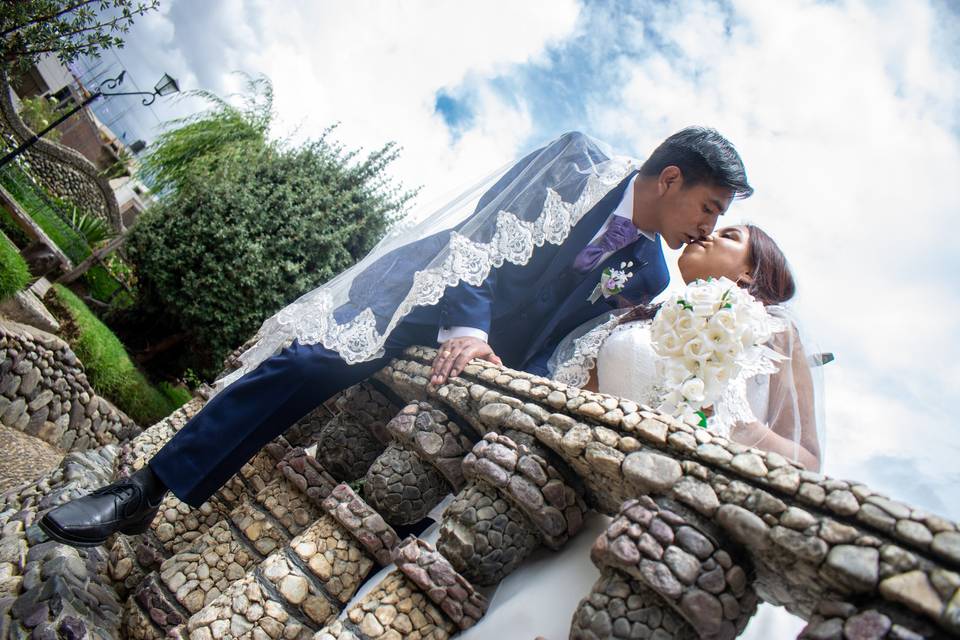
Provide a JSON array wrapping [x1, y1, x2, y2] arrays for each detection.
[[84, 0, 960, 519]]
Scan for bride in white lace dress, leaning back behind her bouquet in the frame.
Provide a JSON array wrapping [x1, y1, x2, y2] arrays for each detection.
[[548, 225, 823, 471]]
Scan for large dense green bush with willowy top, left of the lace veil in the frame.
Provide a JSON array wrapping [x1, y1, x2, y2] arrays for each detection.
[[127, 80, 411, 378]]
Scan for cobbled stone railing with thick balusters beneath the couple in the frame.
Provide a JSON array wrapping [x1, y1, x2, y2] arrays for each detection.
[[0, 348, 960, 640]]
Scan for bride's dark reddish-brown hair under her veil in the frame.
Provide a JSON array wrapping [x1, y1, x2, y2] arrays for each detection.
[[620, 224, 797, 324]]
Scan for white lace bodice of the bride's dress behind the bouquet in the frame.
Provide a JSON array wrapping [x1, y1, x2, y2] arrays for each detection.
[[551, 314, 777, 436]]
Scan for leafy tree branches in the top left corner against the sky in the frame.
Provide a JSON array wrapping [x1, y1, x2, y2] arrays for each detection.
[[0, 0, 159, 70]]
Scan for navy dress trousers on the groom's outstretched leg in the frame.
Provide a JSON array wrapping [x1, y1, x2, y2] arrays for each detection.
[[149, 323, 437, 507]]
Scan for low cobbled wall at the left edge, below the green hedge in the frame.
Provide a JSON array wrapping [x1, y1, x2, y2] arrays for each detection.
[[0, 320, 139, 451]]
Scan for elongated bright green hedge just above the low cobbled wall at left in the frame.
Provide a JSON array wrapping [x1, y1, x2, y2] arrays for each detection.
[[46, 285, 179, 427]]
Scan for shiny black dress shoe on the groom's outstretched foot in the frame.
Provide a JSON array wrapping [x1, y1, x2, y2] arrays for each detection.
[[40, 466, 166, 547]]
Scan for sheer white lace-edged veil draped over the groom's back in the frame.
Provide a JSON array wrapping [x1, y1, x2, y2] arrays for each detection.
[[215, 133, 638, 392]]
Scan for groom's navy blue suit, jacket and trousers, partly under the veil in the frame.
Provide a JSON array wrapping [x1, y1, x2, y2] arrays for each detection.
[[156, 134, 669, 505]]
